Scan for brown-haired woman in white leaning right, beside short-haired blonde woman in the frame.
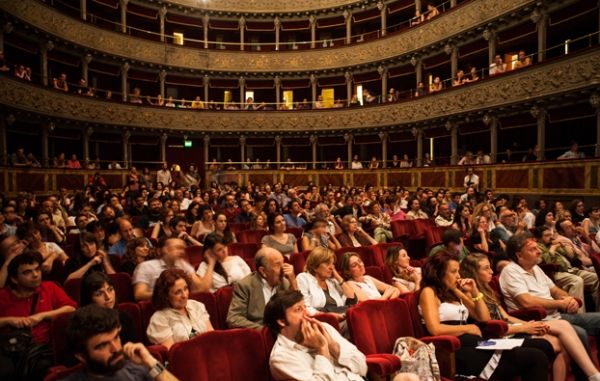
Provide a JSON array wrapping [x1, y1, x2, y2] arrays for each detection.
[[340, 252, 400, 302]]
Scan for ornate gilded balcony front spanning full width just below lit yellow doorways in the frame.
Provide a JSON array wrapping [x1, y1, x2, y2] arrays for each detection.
[[0, 49, 600, 133]]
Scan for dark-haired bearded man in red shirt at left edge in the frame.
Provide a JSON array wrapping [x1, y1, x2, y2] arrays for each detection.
[[0, 252, 77, 380]]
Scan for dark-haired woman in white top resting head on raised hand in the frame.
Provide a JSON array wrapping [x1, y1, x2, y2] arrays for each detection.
[[197, 233, 252, 292]]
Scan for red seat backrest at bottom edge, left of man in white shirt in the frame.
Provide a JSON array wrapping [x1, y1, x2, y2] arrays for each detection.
[[169, 329, 269, 381]]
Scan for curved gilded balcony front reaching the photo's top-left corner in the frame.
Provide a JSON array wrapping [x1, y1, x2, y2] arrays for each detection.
[[0, 0, 533, 73]]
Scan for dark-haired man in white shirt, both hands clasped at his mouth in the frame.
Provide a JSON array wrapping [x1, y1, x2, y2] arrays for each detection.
[[264, 290, 367, 381]]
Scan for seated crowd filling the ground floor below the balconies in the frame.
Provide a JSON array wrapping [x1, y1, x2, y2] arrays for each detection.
[[0, 169, 600, 380]]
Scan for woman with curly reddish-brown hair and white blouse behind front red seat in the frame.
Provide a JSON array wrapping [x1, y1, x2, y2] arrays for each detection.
[[146, 268, 213, 349]]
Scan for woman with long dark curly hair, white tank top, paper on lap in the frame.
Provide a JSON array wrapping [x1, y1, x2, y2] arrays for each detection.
[[419, 251, 553, 381]]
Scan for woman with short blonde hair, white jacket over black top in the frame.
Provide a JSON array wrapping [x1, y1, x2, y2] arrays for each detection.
[[296, 247, 355, 321]]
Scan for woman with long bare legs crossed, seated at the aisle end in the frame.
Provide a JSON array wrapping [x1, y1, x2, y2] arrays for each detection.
[[460, 253, 600, 381]]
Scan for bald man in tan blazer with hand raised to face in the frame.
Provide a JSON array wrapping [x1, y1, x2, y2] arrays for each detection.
[[227, 247, 298, 329]]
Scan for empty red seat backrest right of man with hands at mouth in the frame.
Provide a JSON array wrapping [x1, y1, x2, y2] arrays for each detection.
[[346, 299, 414, 355]]
